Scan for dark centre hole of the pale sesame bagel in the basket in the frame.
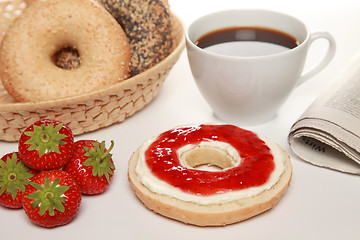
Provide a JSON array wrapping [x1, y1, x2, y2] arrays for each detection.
[[52, 47, 81, 70]]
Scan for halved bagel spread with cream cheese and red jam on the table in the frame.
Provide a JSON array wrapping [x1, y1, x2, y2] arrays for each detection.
[[128, 125, 292, 226]]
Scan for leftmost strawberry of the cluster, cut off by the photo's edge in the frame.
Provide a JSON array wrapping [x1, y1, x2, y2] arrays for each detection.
[[0, 152, 37, 208]]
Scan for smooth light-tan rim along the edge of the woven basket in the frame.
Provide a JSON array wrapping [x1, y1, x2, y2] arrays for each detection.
[[0, 13, 185, 112]]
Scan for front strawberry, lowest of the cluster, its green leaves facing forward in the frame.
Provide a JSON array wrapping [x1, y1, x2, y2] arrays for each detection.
[[23, 170, 81, 228]]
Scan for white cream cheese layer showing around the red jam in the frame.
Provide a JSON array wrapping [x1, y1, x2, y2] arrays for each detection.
[[135, 133, 285, 205]]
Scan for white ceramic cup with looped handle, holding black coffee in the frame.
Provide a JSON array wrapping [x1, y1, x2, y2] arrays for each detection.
[[186, 9, 336, 126]]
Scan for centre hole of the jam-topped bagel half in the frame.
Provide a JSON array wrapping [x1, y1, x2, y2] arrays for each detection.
[[180, 147, 236, 171]]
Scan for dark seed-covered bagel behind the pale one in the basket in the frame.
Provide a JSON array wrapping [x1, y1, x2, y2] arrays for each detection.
[[98, 0, 173, 76]]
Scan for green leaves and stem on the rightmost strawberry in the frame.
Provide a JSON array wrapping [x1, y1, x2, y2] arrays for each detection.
[[83, 141, 115, 182]]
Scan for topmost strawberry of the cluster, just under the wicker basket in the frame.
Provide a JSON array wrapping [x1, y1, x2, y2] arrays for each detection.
[[18, 119, 74, 171]]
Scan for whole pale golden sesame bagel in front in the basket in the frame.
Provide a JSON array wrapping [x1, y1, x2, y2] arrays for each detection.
[[0, 0, 131, 102]]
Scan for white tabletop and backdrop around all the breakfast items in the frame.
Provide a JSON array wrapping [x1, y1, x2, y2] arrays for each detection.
[[0, 0, 360, 240]]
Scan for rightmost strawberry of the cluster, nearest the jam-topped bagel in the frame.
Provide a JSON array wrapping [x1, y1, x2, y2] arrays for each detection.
[[64, 140, 115, 194]]
